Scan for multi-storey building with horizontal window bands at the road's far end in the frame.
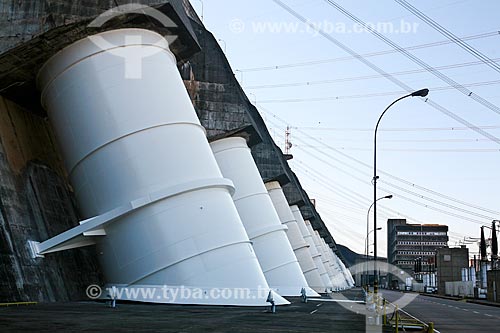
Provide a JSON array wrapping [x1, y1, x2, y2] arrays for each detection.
[[387, 219, 448, 285]]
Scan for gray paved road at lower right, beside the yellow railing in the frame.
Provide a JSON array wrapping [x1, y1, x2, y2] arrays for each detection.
[[382, 290, 500, 333]]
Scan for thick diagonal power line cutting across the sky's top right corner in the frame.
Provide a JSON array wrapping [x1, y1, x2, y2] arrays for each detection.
[[395, 0, 500, 73]]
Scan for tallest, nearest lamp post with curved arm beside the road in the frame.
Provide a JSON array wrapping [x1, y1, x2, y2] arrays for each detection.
[[373, 89, 429, 294]]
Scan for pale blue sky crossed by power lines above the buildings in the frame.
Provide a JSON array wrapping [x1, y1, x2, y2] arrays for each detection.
[[191, 0, 500, 256]]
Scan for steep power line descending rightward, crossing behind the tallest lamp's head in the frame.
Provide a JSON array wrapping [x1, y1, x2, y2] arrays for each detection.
[[272, 0, 500, 144]]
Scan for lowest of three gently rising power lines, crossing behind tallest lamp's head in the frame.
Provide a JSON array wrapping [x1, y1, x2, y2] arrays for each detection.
[[259, 80, 500, 104]]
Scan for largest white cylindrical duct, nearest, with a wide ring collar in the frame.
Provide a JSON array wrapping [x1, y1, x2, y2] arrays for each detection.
[[38, 29, 287, 306]]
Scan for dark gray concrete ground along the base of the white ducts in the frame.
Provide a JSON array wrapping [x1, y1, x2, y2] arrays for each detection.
[[0, 290, 365, 333]]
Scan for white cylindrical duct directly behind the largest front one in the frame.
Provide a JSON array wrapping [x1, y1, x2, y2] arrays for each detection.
[[210, 137, 312, 296]]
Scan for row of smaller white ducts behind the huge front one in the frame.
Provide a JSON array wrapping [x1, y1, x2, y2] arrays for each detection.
[[211, 137, 350, 296]]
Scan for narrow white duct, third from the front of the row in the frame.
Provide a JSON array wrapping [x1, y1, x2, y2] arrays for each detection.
[[266, 182, 322, 294]]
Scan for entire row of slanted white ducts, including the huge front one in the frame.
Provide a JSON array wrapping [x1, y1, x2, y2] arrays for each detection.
[[38, 29, 352, 305]]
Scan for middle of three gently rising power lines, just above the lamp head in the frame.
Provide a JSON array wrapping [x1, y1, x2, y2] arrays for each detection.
[[244, 58, 500, 90]]
